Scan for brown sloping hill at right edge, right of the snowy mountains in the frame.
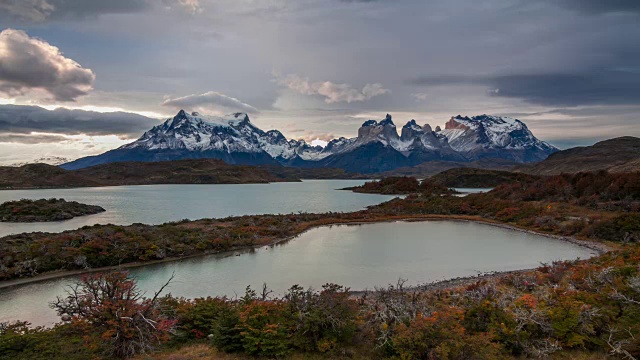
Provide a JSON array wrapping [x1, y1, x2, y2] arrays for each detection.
[[514, 136, 640, 175]]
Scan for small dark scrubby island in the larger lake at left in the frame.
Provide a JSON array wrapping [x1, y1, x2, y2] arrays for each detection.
[[0, 198, 105, 222]]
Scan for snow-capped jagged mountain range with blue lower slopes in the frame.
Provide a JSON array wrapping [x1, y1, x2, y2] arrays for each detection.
[[61, 110, 558, 173]]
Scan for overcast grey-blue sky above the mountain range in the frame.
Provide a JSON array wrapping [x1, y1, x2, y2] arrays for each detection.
[[0, 0, 640, 162]]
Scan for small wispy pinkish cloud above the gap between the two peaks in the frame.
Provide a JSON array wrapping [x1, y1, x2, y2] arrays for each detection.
[[276, 74, 391, 104]]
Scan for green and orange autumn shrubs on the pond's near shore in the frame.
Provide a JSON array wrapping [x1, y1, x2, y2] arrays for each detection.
[[0, 245, 640, 360]]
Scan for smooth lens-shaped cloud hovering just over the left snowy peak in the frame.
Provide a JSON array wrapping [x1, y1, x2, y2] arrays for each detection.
[[162, 91, 258, 113]]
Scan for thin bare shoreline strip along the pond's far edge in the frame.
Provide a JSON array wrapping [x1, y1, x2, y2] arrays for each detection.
[[0, 215, 613, 289]]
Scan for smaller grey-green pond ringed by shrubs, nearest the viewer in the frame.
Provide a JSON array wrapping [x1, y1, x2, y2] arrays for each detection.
[[0, 221, 592, 325]]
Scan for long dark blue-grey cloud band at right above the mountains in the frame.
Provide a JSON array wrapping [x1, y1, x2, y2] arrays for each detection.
[[410, 70, 640, 106]]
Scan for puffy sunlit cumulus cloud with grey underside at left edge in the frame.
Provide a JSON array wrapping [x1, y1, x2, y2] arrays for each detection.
[[0, 29, 95, 101]]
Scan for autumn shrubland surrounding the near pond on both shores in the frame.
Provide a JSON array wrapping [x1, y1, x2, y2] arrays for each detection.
[[0, 172, 640, 360]]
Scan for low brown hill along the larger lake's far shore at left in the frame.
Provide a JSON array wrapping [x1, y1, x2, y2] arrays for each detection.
[[0, 159, 299, 189]]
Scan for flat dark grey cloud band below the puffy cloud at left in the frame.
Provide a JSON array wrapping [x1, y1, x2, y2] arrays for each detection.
[[0, 105, 159, 138]]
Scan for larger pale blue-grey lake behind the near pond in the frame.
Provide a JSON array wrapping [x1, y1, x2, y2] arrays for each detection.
[[0, 180, 394, 236]]
